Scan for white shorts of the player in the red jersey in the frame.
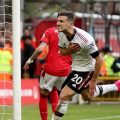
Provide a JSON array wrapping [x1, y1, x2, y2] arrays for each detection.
[[40, 73, 67, 92]]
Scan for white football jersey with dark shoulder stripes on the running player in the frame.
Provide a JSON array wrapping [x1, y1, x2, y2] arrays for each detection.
[[59, 27, 98, 72]]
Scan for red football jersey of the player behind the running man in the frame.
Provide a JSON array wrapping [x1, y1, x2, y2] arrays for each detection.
[[40, 28, 72, 77]]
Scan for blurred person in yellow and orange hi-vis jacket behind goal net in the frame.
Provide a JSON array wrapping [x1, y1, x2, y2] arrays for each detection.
[[0, 40, 13, 80]]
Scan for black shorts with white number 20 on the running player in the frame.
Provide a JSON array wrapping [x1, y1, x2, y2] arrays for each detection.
[[66, 71, 93, 94]]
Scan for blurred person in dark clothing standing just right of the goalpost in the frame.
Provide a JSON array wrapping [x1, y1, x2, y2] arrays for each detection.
[[21, 26, 37, 78]]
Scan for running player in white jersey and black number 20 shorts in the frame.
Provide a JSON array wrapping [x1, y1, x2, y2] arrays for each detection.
[[54, 11, 118, 120]]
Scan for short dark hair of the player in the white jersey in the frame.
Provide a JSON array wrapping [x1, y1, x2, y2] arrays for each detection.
[[57, 11, 75, 21]]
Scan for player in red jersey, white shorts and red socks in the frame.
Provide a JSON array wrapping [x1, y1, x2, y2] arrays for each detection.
[[24, 28, 71, 120]]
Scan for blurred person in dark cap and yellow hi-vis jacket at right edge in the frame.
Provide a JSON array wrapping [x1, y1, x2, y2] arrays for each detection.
[[100, 45, 120, 76]]
